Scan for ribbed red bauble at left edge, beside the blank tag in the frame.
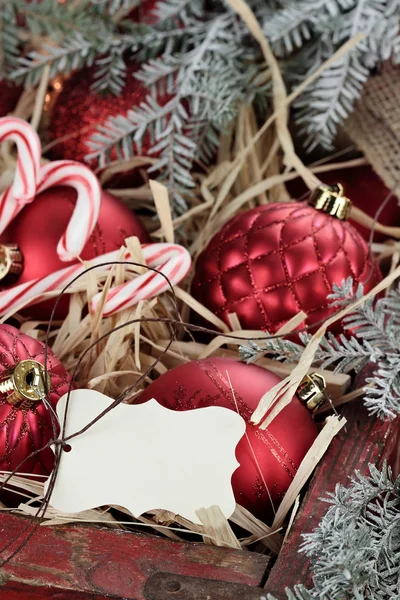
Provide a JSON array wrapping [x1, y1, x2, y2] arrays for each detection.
[[0, 325, 70, 474]]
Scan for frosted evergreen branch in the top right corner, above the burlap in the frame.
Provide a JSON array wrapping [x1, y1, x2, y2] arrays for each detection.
[[264, 0, 400, 149]]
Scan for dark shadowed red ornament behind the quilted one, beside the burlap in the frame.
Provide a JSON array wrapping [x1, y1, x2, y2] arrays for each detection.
[[287, 165, 400, 242]]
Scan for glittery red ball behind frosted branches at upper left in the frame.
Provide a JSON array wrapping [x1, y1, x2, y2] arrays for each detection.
[[48, 66, 149, 168]]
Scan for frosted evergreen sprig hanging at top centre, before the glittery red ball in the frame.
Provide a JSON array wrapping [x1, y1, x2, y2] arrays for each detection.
[[90, 9, 257, 214]]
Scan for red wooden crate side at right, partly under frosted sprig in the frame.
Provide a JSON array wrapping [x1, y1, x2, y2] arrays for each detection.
[[265, 401, 400, 600]]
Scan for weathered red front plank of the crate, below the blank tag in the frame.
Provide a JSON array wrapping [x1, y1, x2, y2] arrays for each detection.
[[0, 514, 268, 600]]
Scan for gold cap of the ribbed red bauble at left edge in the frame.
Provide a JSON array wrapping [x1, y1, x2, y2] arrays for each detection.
[[0, 359, 51, 408]]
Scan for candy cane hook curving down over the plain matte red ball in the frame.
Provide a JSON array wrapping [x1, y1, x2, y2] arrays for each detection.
[[36, 160, 101, 262]]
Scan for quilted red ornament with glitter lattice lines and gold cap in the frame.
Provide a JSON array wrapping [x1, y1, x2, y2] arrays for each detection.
[[192, 188, 382, 333]]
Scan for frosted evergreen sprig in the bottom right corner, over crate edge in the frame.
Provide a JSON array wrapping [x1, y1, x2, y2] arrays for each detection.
[[268, 465, 400, 600]]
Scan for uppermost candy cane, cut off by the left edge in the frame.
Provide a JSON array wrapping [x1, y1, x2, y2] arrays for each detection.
[[0, 117, 41, 233]]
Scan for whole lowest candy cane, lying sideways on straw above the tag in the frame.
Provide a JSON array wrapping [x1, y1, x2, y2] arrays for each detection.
[[0, 244, 191, 316]]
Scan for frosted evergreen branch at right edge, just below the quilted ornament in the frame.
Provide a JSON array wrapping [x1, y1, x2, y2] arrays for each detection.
[[240, 278, 400, 419]]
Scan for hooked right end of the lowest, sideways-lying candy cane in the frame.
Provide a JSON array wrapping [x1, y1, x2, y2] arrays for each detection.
[[90, 243, 192, 317]]
